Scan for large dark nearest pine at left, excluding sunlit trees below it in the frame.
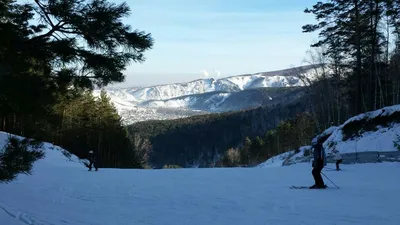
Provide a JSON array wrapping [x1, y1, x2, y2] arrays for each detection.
[[0, 0, 153, 136]]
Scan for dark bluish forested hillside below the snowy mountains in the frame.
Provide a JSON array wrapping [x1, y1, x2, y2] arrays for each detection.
[[128, 96, 309, 168]]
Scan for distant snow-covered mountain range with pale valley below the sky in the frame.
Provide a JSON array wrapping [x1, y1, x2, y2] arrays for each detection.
[[93, 65, 319, 124]]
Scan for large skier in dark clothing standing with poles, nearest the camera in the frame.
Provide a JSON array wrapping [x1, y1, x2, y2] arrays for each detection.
[[309, 138, 326, 189]]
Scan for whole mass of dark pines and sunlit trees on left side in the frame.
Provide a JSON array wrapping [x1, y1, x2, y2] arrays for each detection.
[[0, 0, 153, 175]]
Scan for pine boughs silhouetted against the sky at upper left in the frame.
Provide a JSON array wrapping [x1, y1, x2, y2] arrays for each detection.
[[25, 0, 153, 87]]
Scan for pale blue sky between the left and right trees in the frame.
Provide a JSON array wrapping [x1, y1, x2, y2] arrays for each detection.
[[111, 0, 317, 87]]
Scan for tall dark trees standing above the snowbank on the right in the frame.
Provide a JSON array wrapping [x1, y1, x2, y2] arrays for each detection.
[[303, 0, 400, 131]]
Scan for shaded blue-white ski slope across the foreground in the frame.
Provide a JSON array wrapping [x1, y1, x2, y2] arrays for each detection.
[[0, 134, 400, 225]]
